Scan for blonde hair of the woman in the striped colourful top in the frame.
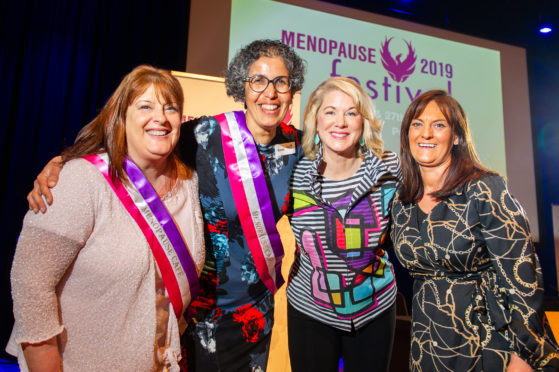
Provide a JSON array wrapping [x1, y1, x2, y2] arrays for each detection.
[[302, 77, 384, 160]]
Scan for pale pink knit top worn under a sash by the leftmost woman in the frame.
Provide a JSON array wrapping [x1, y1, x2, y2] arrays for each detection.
[[7, 159, 205, 371]]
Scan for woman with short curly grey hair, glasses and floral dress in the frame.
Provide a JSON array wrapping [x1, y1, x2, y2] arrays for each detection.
[[28, 40, 305, 372]]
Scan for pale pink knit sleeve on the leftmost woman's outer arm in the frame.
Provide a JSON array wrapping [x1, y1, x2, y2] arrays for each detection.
[[11, 162, 94, 344]]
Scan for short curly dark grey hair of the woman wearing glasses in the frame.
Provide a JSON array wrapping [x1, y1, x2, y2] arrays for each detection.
[[225, 39, 306, 102]]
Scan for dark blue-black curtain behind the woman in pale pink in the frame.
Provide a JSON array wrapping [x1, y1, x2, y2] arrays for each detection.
[[0, 0, 190, 357]]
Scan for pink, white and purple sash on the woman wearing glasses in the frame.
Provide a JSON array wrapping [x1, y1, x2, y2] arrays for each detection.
[[215, 111, 284, 293]]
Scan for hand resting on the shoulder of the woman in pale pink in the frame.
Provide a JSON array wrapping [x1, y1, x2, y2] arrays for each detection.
[[27, 156, 63, 213]]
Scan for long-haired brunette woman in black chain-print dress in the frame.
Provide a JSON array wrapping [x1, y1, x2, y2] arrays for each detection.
[[392, 90, 559, 371]]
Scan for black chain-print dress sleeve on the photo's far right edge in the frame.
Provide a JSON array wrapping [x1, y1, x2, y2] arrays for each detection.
[[470, 176, 559, 371]]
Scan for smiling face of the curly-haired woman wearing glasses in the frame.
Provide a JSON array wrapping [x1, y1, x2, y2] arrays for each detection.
[[245, 57, 293, 140]]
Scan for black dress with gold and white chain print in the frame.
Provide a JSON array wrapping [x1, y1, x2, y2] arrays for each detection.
[[392, 175, 559, 372]]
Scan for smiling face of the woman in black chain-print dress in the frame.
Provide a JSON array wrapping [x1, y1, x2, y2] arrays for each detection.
[[408, 101, 458, 171]]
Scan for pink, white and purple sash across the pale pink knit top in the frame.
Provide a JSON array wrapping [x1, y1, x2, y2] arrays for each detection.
[[84, 153, 200, 319]]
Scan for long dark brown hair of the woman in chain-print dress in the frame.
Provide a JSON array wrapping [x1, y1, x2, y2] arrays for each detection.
[[399, 90, 496, 203]]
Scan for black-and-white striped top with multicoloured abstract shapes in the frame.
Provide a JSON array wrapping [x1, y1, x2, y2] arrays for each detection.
[[287, 151, 401, 331]]
